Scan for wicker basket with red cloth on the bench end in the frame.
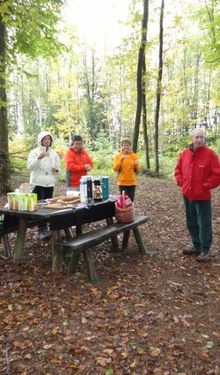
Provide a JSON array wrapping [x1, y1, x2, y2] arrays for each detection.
[[115, 191, 134, 223]]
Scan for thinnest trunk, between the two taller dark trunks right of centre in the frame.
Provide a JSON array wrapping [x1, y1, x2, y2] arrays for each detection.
[[142, 55, 150, 169]]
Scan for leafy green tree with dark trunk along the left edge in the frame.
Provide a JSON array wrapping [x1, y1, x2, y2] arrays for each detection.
[[0, 0, 65, 192]]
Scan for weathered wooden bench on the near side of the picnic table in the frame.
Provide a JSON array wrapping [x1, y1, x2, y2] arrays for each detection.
[[54, 216, 149, 281]]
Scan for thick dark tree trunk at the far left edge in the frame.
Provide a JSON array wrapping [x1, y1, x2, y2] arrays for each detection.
[[0, 16, 10, 193]]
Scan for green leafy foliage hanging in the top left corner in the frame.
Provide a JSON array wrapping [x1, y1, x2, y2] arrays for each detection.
[[0, 0, 65, 64]]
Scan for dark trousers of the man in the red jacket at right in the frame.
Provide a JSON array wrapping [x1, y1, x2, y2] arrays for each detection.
[[183, 197, 212, 253]]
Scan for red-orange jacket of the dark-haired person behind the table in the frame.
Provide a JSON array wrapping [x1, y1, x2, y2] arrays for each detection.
[[65, 147, 93, 187]]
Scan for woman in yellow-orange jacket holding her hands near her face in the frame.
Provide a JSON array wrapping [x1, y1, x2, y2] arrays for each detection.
[[113, 138, 141, 202]]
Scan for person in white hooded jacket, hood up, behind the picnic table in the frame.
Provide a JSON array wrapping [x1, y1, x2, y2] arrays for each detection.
[[27, 131, 60, 239]]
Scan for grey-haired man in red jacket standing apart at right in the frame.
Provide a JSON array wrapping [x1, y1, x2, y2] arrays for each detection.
[[174, 128, 220, 262]]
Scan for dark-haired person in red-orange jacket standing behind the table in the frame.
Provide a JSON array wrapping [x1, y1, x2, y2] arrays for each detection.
[[65, 135, 93, 191]]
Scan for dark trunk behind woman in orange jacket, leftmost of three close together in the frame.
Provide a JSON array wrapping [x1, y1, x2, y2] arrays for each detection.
[[132, 0, 149, 152]]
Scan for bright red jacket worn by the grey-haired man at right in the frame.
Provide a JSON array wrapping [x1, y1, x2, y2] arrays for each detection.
[[174, 146, 220, 201]]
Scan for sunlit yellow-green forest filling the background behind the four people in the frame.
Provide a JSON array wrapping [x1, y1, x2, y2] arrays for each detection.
[[0, 0, 220, 191]]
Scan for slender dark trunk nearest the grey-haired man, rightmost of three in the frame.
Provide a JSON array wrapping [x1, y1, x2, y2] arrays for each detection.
[[154, 0, 164, 173]]
